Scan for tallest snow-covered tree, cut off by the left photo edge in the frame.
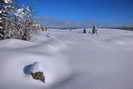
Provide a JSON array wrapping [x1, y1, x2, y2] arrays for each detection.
[[0, 0, 13, 40]]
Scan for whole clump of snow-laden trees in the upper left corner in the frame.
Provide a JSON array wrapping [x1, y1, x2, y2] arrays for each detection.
[[0, 0, 33, 40]]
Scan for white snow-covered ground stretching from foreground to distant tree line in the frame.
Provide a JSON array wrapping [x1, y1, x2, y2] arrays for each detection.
[[0, 29, 133, 89]]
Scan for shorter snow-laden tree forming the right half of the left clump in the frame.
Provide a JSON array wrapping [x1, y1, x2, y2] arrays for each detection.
[[15, 7, 33, 40]]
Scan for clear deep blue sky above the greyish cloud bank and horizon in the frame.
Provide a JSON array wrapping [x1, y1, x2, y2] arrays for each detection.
[[18, 0, 133, 26]]
